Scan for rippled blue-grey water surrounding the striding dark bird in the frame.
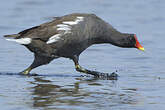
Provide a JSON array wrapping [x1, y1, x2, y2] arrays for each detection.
[[0, 0, 165, 110]]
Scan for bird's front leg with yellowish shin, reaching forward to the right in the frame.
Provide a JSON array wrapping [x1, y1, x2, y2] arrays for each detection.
[[73, 56, 118, 80]]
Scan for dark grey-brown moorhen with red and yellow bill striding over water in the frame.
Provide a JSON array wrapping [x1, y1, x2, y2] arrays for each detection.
[[4, 13, 144, 76]]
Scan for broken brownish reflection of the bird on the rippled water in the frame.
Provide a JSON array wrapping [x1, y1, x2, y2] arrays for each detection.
[[31, 77, 140, 109]]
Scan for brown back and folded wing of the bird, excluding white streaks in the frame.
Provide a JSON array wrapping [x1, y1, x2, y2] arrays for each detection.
[[6, 14, 89, 42]]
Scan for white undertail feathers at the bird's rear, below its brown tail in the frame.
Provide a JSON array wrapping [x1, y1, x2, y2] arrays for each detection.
[[6, 38, 32, 45]]
